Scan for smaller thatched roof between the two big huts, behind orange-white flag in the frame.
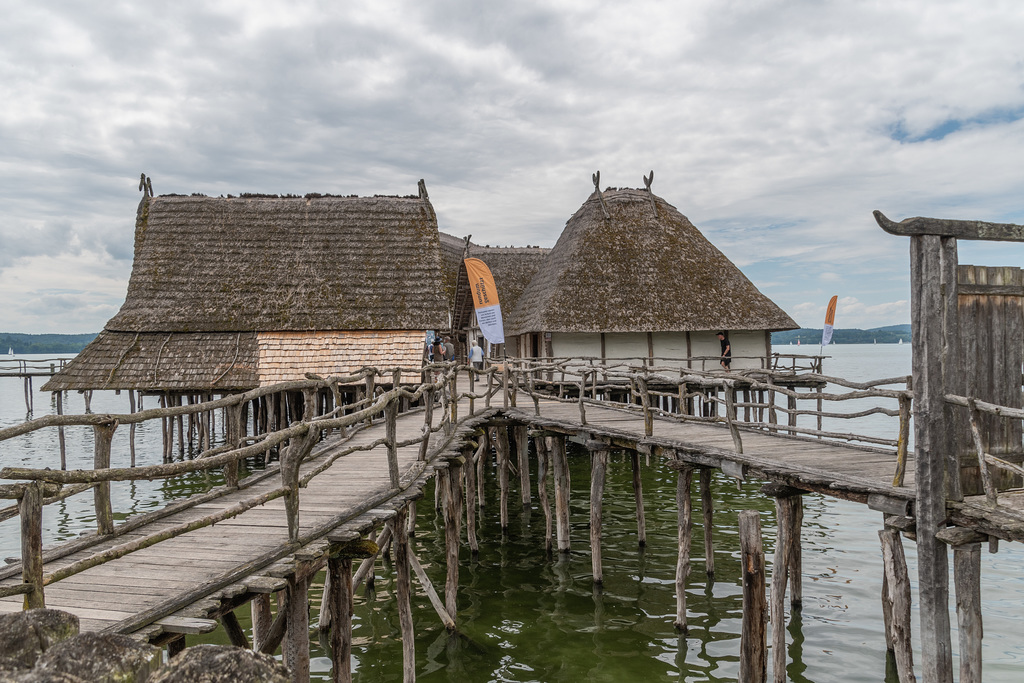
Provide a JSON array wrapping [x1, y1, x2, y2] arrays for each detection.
[[440, 232, 551, 330]]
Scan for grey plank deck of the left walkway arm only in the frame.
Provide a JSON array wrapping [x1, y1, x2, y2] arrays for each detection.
[[0, 403, 487, 637]]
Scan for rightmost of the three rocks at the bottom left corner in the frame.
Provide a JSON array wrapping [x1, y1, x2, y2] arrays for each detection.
[[151, 645, 291, 683]]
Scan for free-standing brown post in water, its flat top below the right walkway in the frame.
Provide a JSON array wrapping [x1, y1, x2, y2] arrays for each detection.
[[739, 510, 768, 683]]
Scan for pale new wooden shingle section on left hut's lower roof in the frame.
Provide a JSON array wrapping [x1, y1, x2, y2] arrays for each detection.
[[256, 330, 426, 385]]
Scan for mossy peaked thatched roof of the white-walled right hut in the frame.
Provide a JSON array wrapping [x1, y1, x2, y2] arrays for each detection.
[[505, 189, 798, 335]]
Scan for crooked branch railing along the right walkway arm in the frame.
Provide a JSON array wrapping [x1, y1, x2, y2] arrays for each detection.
[[509, 358, 913, 486]]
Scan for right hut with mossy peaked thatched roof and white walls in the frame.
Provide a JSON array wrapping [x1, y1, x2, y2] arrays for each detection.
[[505, 183, 798, 367]]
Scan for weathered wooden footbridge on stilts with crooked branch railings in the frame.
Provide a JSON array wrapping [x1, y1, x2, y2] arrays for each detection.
[[0, 359, 1024, 680]]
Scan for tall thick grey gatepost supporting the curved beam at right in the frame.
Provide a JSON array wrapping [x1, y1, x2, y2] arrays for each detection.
[[910, 234, 962, 683]]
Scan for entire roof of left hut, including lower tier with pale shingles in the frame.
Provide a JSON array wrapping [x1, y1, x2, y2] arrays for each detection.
[[43, 183, 447, 392]]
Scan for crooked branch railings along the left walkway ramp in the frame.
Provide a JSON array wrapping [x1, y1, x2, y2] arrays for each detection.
[[0, 362, 499, 608]]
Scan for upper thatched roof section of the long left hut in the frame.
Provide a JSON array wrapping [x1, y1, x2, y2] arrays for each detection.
[[106, 194, 447, 333]]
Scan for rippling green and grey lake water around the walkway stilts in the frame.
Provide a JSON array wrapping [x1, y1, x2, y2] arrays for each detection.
[[0, 345, 1024, 682]]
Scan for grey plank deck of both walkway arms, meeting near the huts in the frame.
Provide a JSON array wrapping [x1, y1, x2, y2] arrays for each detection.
[[0, 387, 1024, 639]]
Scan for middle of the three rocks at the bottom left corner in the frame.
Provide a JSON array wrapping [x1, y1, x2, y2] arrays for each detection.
[[36, 633, 163, 683]]
